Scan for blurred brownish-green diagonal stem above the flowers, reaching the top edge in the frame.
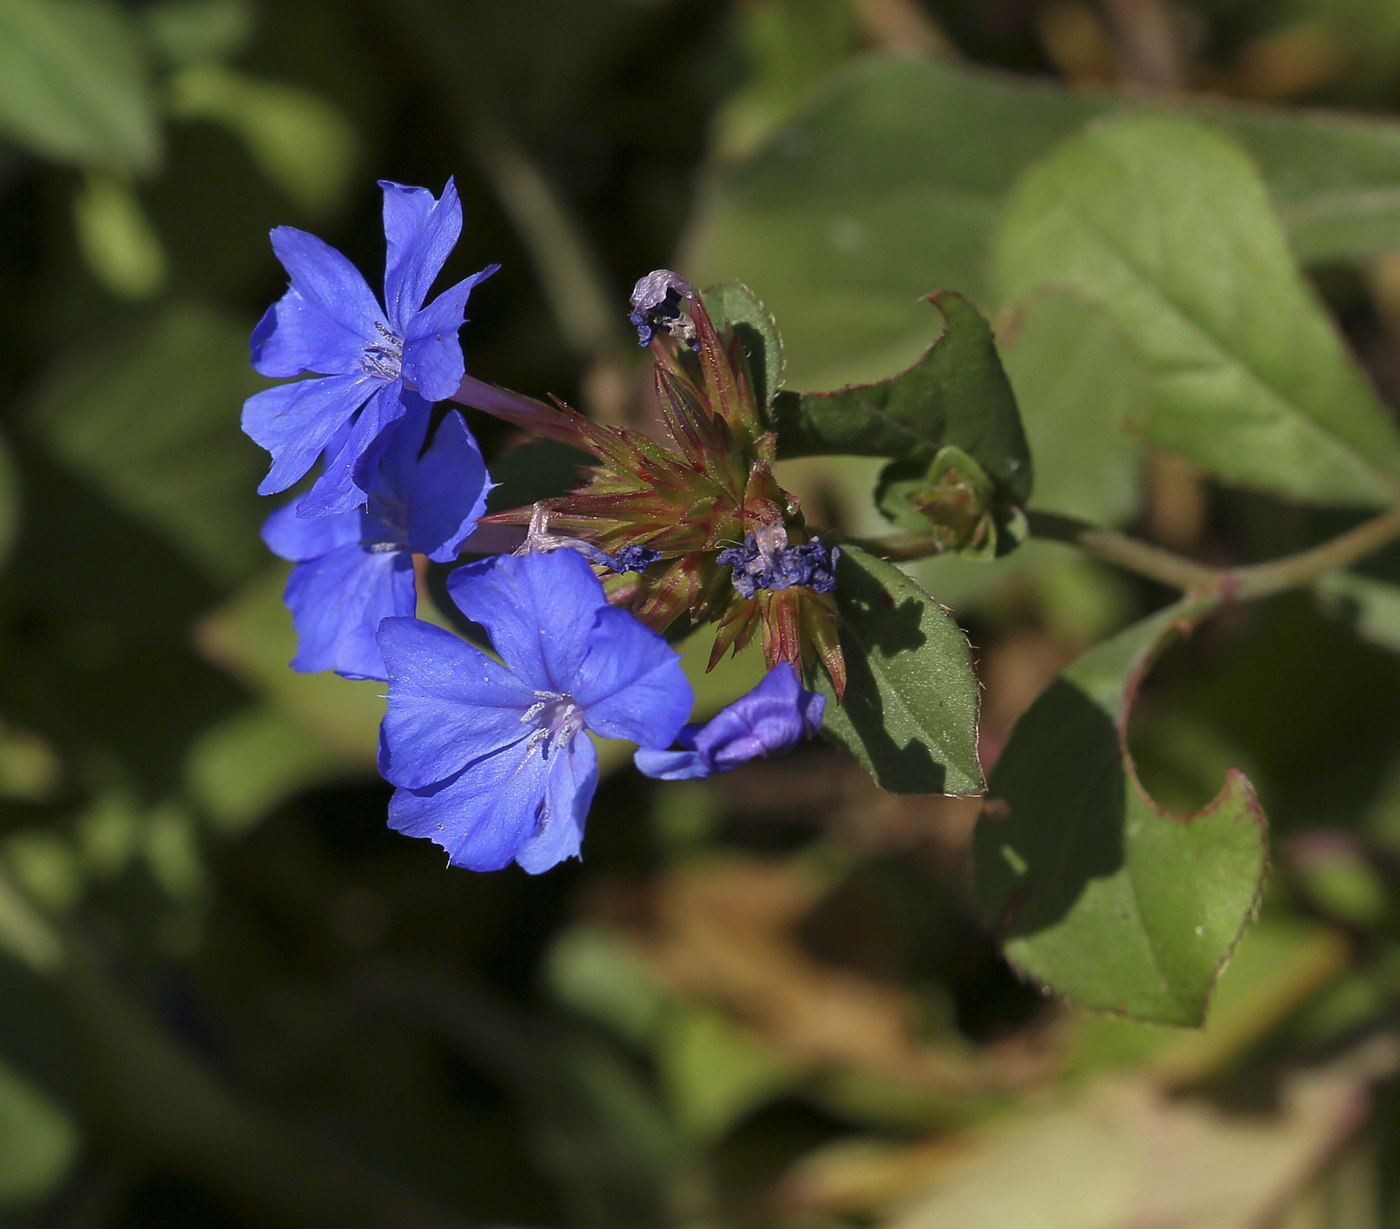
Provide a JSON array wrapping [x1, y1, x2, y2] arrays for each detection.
[[384, 0, 622, 360]]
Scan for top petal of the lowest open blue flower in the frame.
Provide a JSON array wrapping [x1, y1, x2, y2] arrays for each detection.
[[447, 550, 608, 694]]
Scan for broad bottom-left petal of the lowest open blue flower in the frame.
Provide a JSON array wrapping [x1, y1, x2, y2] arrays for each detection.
[[389, 738, 563, 871]]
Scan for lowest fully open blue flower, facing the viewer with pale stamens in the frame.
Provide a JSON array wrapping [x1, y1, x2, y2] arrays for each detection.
[[379, 550, 694, 875]]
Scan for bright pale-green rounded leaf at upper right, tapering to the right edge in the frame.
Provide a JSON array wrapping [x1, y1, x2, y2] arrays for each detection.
[[995, 115, 1400, 504]]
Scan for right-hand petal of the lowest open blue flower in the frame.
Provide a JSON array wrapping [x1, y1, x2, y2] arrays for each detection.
[[574, 607, 696, 747]]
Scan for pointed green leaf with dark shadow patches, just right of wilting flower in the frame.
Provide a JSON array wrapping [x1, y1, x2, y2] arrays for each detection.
[[818, 546, 983, 794]]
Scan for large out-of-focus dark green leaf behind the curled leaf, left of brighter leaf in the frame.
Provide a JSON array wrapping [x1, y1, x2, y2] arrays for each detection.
[[685, 57, 1099, 388]]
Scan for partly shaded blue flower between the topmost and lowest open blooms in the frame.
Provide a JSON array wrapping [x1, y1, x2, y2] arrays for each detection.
[[263, 392, 489, 679]]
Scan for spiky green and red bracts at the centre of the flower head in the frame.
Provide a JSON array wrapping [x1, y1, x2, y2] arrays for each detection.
[[458, 274, 846, 697]]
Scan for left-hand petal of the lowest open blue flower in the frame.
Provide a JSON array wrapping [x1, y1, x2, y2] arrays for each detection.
[[379, 619, 535, 789]]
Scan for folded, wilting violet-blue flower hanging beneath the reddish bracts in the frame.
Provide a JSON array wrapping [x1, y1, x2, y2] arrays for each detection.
[[634, 662, 826, 781]]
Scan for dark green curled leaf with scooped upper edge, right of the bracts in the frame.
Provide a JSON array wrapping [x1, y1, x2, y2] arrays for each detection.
[[773, 293, 1030, 503]]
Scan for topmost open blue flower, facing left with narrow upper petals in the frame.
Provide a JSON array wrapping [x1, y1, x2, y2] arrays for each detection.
[[244, 179, 500, 517]]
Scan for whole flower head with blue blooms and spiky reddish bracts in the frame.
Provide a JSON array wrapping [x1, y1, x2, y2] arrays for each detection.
[[244, 181, 844, 872]]
